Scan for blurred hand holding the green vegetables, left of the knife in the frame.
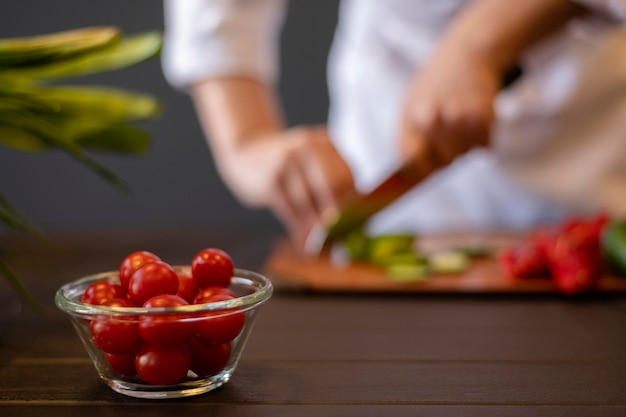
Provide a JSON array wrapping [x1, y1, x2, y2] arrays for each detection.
[[226, 127, 354, 248]]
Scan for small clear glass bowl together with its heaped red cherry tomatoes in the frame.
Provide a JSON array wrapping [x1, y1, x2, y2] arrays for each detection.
[[55, 248, 272, 399]]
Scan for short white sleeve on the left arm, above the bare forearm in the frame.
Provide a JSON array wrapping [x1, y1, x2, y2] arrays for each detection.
[[161, 0, 286, 89]]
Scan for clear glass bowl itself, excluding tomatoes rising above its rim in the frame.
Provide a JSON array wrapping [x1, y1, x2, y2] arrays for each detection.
[[55, 266, 273, 399]]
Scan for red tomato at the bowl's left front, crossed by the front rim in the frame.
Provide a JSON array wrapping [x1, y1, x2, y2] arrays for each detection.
[[89, 298, 141, 355]]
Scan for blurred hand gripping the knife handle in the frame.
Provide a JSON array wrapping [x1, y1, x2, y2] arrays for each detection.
[[399, 48, 501, 175]]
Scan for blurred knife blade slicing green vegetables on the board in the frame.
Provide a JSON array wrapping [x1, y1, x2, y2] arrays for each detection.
[[304, 161, 430, 256]]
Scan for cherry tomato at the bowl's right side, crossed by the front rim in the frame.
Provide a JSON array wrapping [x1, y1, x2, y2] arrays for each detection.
[[196, 294, 246, 345]]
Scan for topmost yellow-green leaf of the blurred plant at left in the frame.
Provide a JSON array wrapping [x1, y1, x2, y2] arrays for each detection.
[[0, 32, 162, 79]]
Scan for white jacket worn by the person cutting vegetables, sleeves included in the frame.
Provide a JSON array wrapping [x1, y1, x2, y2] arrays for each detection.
[[163, 0, 626, 233]]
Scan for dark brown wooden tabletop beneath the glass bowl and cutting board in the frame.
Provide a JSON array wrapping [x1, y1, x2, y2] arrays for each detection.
[[0, 230, 626, 417]]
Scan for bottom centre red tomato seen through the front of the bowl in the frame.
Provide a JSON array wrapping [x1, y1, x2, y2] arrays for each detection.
[[135, 343, 191, 385]]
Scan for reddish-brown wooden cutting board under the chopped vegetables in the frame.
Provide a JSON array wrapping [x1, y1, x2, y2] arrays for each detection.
[[264, 235, 626, 293]]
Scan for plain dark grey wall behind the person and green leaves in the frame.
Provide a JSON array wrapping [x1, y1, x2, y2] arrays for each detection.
[[0, 0, 338, 232]]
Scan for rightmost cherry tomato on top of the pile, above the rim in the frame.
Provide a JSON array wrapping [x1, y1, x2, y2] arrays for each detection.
[[191, 248, 235, 288]]
